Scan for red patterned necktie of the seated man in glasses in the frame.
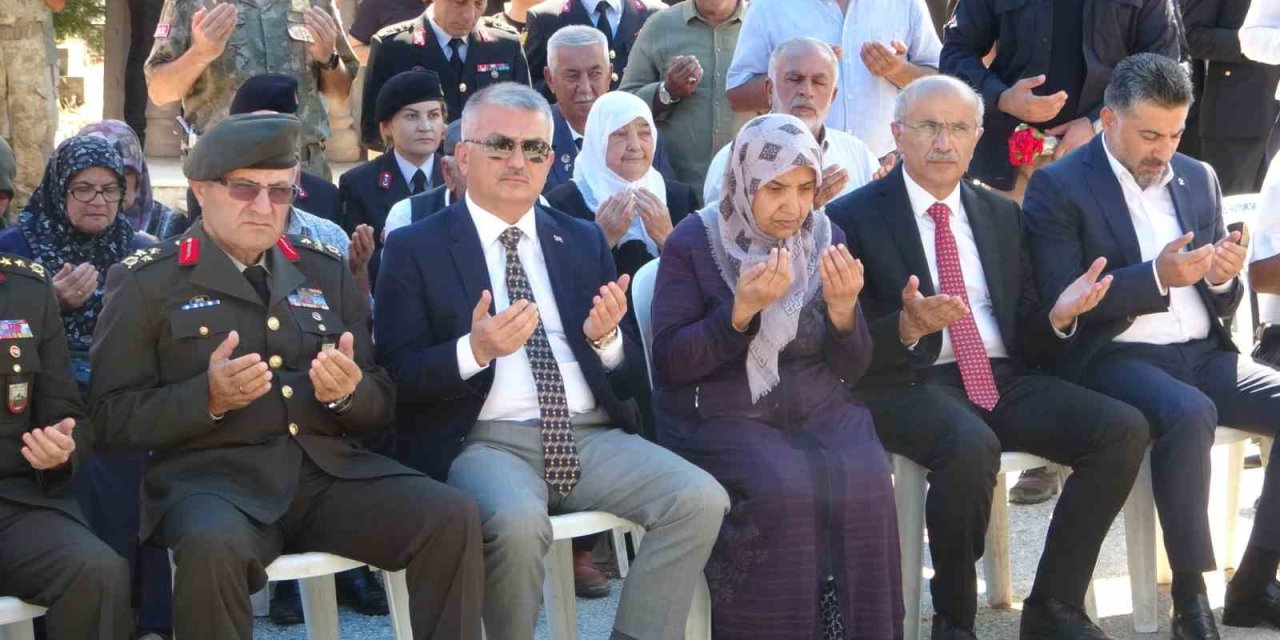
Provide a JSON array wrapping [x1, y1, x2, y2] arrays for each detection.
[[928, 202, 1000, 411]]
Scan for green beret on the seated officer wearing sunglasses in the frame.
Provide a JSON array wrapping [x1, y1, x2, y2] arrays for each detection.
[[182, 114, 302, 180]]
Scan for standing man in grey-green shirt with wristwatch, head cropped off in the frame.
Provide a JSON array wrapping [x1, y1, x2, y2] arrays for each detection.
[[620, 0, 746, 186]]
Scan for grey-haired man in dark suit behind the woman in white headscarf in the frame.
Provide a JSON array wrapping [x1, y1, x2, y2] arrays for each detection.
[[543, 24, 676, 193]]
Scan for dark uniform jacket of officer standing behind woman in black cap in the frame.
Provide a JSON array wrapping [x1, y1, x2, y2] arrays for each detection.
[[360, 13, 529, 151]]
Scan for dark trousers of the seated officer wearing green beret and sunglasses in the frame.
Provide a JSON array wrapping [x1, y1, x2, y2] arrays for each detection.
[[155, 460, 484, 640]]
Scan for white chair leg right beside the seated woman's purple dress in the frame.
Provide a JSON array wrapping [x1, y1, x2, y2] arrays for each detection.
[[892, 456, 928, 640]]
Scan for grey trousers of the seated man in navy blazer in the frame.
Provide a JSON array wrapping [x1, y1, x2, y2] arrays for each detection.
[[449, 422, 728, 640]]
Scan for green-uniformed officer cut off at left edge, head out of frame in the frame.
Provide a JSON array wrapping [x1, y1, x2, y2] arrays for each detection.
[[0, 253, 133, 640]]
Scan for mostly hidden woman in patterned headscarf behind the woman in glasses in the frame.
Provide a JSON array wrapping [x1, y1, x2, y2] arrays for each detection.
[[78, 120, 191, 238]]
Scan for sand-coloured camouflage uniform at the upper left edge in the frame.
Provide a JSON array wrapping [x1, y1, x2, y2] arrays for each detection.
[[0, 0, 58, 211]]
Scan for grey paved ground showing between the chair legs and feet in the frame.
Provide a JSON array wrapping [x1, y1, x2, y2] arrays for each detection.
[[247, 458, 1280, 640]]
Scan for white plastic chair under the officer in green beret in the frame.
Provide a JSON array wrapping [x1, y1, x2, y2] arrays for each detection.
[[169, 550, 409, 640]]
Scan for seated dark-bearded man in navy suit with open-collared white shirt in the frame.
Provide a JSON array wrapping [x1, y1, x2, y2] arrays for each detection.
[[1024, 54, 1280, 639]]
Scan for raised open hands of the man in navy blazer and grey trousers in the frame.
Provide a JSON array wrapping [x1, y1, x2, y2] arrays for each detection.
[[470, 274, 631, 366]]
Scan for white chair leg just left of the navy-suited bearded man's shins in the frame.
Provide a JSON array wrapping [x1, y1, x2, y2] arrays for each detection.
[[1124, 451, 1160, 634]]
